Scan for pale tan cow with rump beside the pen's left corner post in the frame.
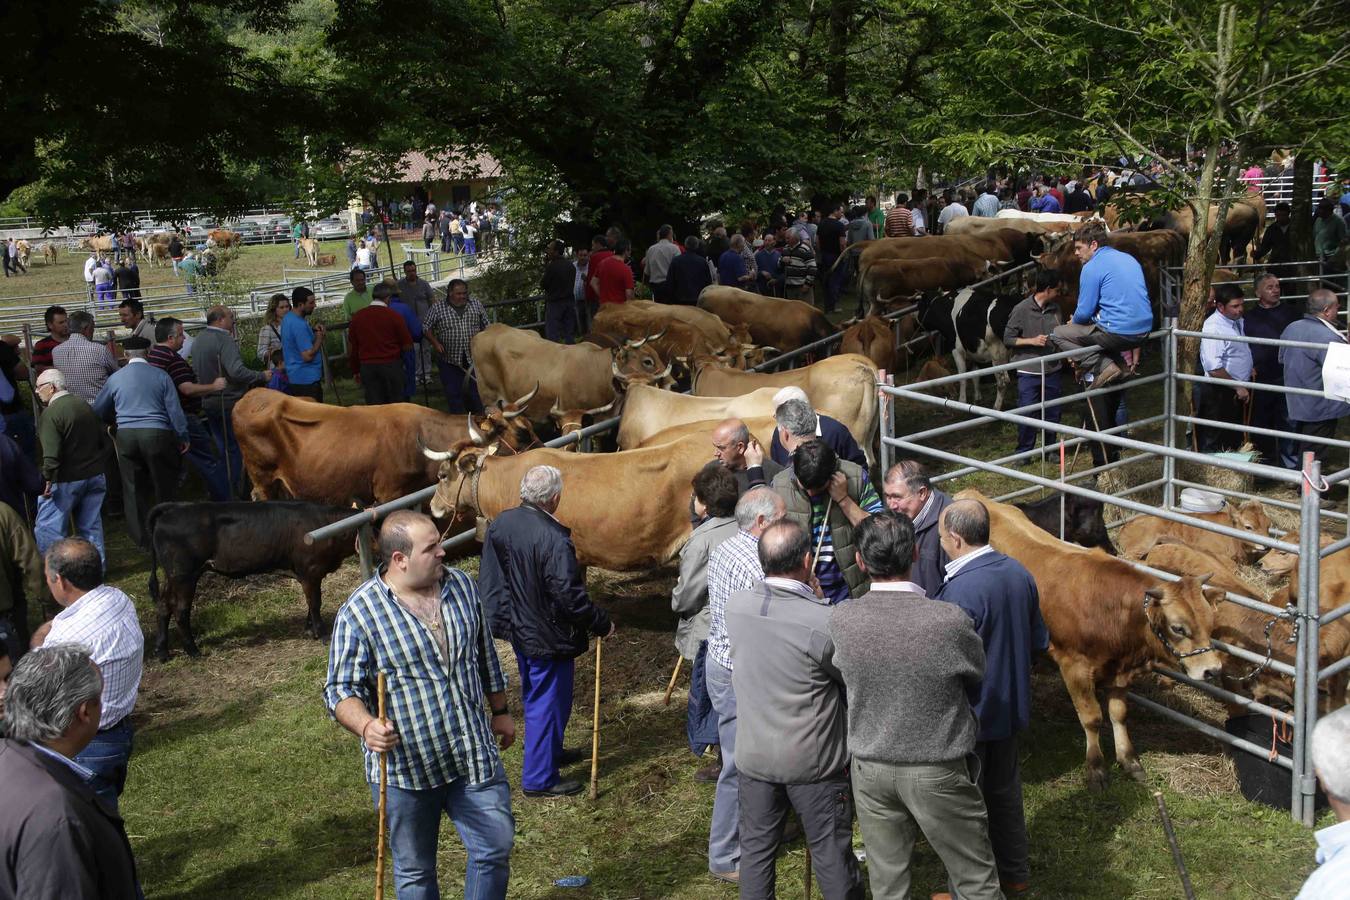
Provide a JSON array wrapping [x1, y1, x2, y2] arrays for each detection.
[[691, 354, 880, 466]]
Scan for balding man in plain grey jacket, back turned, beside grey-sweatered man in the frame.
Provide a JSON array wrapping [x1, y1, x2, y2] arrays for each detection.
[[726, 519, 863, 900]]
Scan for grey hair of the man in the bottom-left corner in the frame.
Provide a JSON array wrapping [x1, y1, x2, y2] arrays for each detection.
[[4, 644, 103, 743]]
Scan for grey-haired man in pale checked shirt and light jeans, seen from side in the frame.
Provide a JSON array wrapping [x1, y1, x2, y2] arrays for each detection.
[[705, 487, 786, 884]]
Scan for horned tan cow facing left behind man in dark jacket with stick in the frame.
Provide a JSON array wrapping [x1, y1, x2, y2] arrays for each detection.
[[425, 436, 711, 572]]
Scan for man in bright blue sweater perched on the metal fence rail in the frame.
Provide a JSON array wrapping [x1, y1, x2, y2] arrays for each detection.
[[1050, 223, 1153, 387]]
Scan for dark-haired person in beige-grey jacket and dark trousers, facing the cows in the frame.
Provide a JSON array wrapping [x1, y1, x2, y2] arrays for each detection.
[[671, 464, 740, 783]]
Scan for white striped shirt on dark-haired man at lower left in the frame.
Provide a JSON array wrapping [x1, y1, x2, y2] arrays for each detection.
[[43, 584, 146, 729]]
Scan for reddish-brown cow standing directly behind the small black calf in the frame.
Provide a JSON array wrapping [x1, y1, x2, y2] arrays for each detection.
[[234, 390, 539, 505]]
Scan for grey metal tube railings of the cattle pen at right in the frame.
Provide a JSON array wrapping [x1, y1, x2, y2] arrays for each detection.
[[879, 302, 1350, 826]]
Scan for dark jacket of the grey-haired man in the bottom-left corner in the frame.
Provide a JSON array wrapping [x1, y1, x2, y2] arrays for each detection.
[[0, 741, 136, 900]]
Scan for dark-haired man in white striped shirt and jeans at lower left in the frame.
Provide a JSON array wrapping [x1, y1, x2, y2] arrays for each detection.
[[32, 537, 146, 810]]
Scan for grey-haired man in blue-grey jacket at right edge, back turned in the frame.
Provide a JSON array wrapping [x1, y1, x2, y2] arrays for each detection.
[[1280, 287, 1350, 474]]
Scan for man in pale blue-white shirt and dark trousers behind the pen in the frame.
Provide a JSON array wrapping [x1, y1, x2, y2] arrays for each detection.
[[1196, 282, 1251, 453]]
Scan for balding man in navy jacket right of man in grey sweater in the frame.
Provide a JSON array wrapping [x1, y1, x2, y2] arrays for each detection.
[[936, 501, 1050, 893]]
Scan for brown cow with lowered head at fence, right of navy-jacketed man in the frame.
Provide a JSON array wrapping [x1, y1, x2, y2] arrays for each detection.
[[957, 490, 1223, 789]]
